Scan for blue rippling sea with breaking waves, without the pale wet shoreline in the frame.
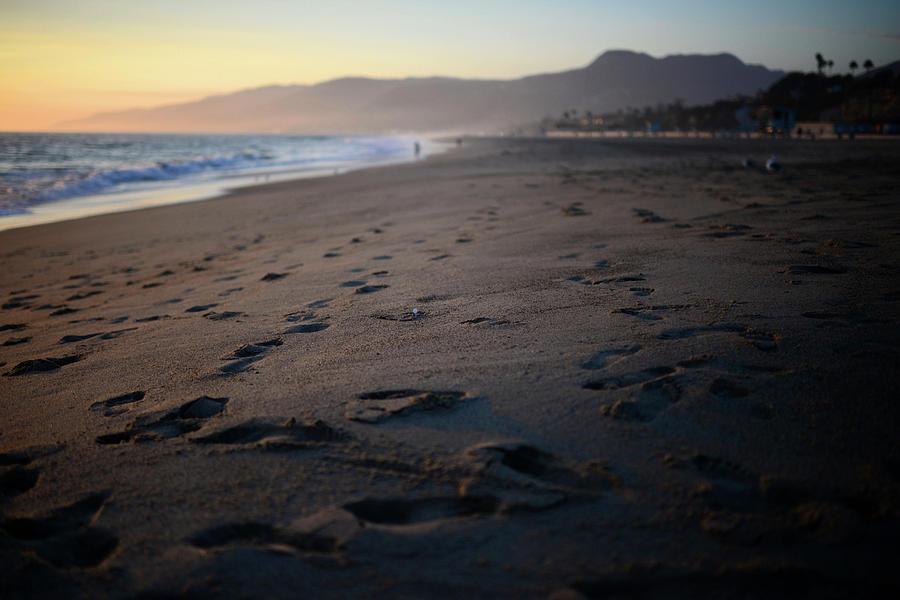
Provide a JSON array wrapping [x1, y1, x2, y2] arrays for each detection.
[[0, 134, 408, 216]]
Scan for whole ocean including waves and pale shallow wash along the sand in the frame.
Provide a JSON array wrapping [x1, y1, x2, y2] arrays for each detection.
[[0, 133, 441, 230]]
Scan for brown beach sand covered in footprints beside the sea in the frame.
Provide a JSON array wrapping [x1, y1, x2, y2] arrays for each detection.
[[0, 139, 900, 600]]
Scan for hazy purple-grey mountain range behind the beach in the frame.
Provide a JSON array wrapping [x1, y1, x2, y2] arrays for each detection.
[[60, 50, 784, 134]]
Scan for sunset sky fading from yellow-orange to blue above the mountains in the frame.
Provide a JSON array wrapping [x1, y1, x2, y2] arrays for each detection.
[[0, 0, 900, 131]]
